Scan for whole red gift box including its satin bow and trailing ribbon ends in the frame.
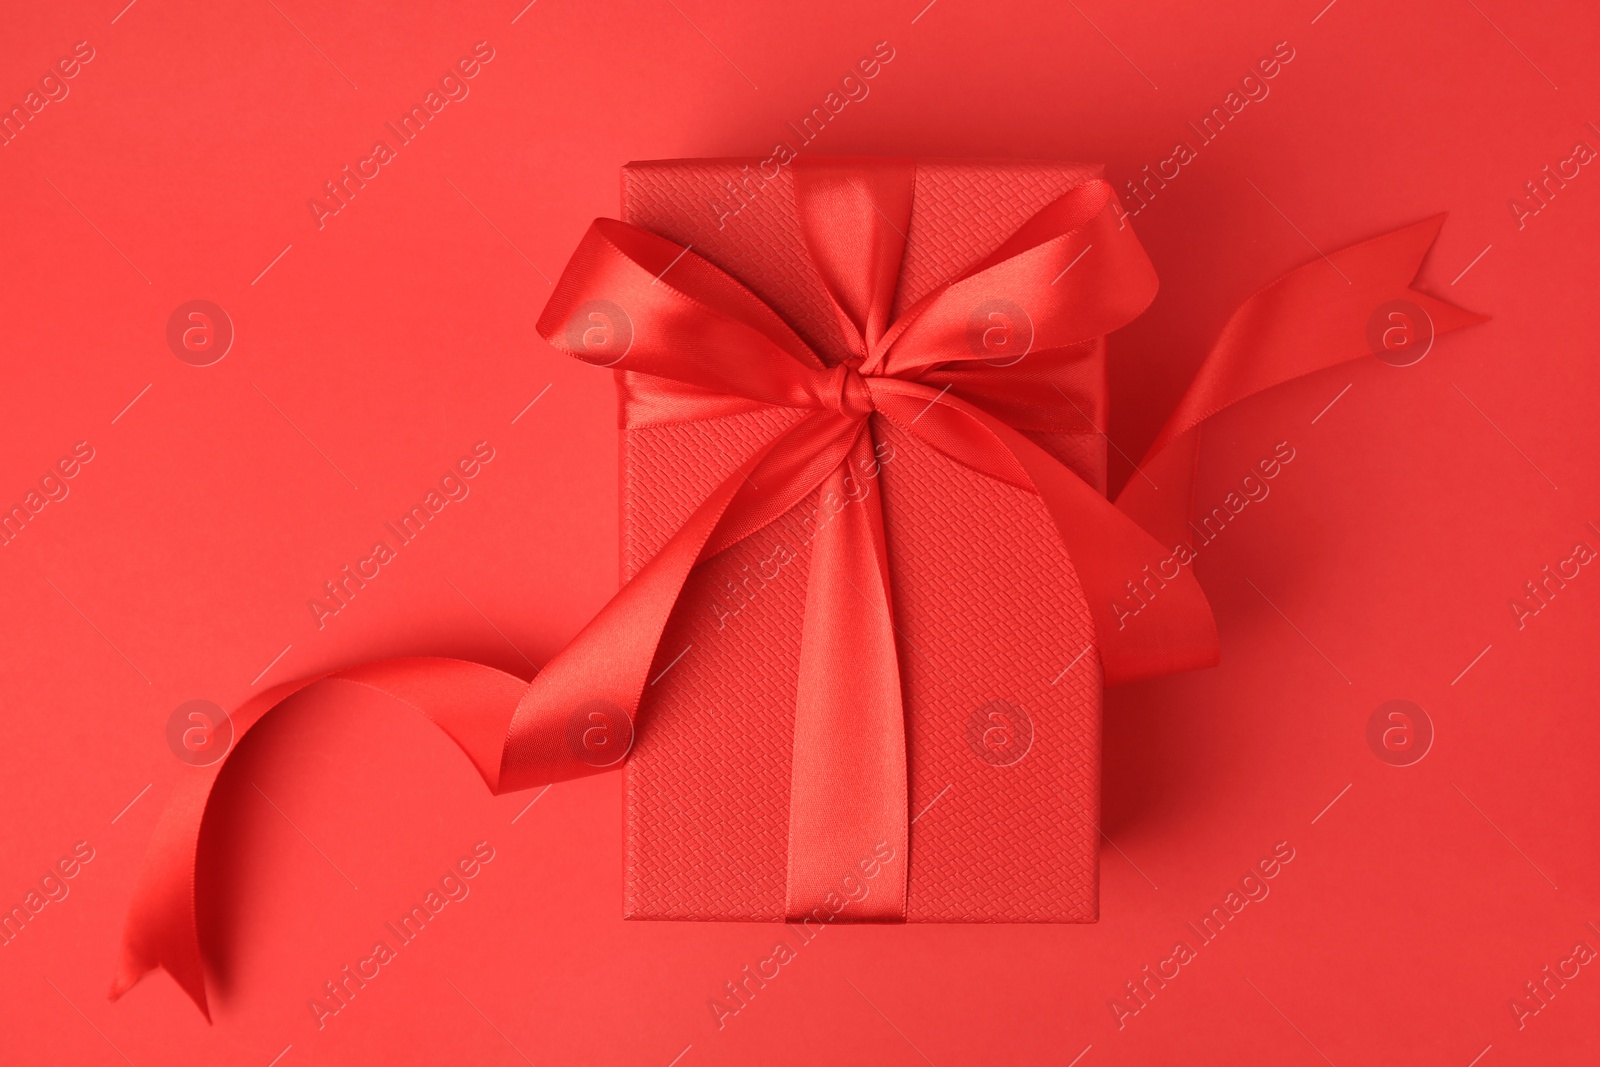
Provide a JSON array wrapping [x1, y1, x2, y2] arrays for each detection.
[[112, 160, 1482, 1011]]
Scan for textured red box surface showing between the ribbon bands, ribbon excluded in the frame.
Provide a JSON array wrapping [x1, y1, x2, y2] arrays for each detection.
[[618, 160, 1106, 923]]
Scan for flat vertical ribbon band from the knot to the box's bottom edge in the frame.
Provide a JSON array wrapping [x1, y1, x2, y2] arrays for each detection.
[[784, 434, 909, 921]]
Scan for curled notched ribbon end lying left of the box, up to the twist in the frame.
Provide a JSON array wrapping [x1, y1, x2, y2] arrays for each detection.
[[109, 659, 526, 1022]]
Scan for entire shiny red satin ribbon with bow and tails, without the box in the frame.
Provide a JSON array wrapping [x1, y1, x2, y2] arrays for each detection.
[[110, 160, 1478, 1019]]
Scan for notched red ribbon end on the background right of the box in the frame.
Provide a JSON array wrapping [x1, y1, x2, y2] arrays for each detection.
[[1117, 214, 1488, 544]]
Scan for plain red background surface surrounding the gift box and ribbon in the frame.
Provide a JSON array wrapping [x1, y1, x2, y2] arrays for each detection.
[[0, 0, 1600, 1067]]
